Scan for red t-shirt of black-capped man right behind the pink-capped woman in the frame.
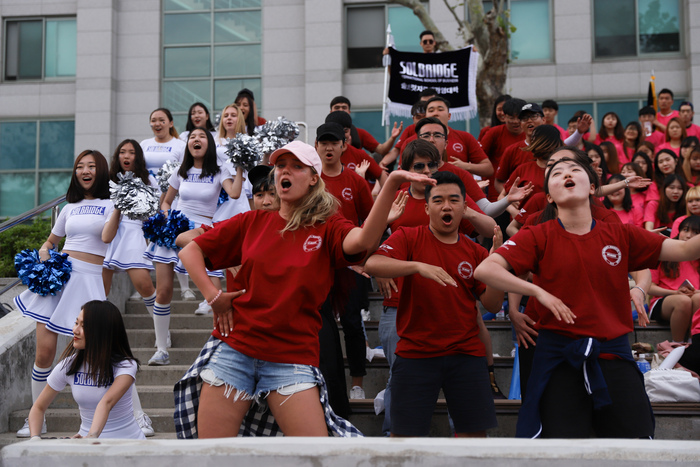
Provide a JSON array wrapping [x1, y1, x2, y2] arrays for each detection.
[[321, 167, 374, 226]]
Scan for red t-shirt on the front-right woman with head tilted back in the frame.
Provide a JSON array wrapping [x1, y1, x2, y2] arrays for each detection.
[[496, 219, 664, 341]]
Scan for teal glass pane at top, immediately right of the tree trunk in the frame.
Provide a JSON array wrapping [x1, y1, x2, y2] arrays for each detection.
[[510, 0, 552, 60]]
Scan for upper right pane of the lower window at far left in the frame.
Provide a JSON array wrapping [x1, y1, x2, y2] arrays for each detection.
[[39, 121, 75, 169]]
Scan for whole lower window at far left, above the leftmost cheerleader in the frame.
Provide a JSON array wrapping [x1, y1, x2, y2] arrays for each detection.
[[0, 120, 75, 217]]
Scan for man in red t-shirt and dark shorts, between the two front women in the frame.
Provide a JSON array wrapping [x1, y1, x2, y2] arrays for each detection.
[[365, 172, 503, 436]]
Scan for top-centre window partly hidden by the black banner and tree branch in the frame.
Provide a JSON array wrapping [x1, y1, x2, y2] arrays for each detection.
[[345, 4, 427, 69]]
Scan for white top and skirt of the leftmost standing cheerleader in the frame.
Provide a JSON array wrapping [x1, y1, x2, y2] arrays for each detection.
[[14, 199, 114, 336]]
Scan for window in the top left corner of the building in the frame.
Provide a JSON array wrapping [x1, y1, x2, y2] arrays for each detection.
[[5, 18, 76, 81]]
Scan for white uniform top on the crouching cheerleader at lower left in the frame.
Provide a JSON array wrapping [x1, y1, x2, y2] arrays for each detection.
[[46, 357, 146, 439]]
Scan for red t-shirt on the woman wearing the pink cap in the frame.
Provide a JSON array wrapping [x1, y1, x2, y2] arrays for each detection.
[[194, 210, 365, 366]]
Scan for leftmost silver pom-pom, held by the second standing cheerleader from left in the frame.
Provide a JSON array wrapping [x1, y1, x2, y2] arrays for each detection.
[[109, 172, 159, 220]]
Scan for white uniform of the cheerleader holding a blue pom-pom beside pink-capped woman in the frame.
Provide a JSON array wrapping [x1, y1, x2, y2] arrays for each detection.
[[144, 167, 231, 277]]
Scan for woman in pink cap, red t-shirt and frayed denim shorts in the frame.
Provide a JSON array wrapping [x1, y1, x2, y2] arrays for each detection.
[[180, 141, 434, 438]]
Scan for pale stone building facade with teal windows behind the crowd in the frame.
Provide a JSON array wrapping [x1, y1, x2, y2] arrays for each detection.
[[0, 0, 700, 217]]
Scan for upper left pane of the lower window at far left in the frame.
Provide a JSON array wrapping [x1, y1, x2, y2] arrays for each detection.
[[0, 122, 36, 170]]
